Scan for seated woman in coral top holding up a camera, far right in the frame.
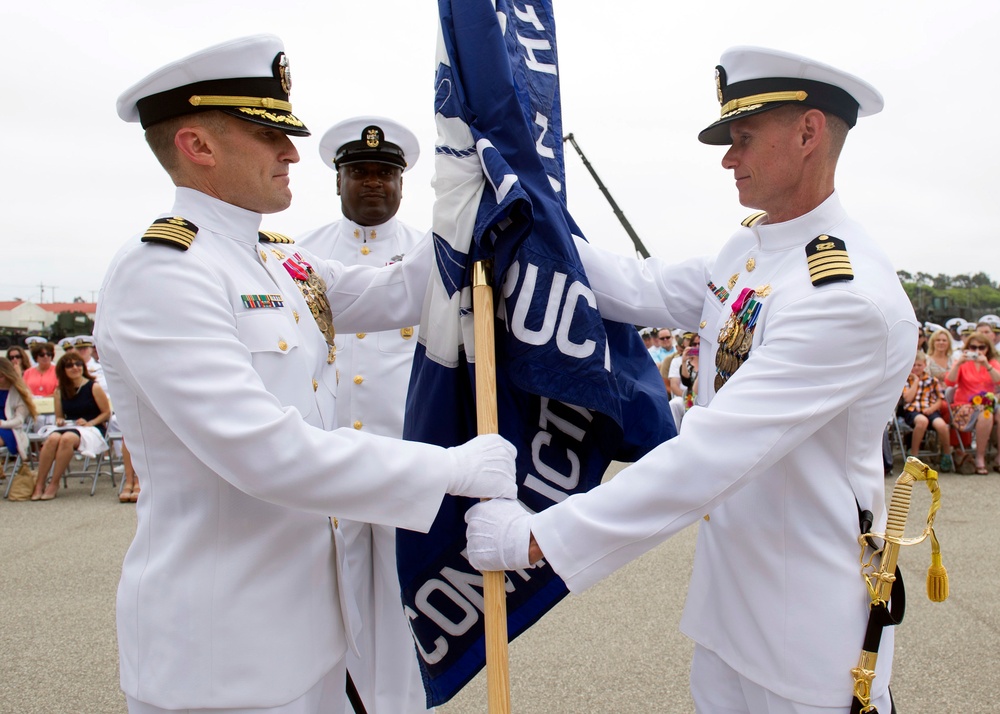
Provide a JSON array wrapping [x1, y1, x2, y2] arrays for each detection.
[[944, 332, 1000, 474]]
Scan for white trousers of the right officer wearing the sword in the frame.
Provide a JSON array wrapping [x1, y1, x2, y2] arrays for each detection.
[[691, 645, 892, 714]]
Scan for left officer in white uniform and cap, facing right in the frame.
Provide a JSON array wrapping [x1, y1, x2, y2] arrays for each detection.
[[96, 35, 513, 714]]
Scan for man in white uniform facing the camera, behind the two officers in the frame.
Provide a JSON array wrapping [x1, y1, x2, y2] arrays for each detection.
[[296, 116, 427, 714]]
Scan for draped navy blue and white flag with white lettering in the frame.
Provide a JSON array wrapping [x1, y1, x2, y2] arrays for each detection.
[[397, 0, 676, 706]]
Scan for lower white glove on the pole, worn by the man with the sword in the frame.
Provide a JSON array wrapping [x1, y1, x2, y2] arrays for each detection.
[[465, 498, 532, 572]]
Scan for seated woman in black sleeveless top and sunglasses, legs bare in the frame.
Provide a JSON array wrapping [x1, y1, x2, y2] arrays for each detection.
[[31, 351, 111, 501]]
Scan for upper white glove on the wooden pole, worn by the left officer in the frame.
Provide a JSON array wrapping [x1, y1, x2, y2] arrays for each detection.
[[447, 434, 517, 498]]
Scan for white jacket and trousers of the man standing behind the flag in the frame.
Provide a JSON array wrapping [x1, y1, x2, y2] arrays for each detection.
[[296, 217, 427, 714]]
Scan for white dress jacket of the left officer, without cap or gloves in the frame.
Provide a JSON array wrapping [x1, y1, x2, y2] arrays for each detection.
[[96, 188, 455, 709]]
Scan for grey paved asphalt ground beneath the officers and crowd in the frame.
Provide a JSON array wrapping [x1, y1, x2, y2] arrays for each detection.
[[0, 458, 1000, 714]]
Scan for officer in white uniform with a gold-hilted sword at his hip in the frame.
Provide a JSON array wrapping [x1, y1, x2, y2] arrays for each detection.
[[469, 48, 917, 714]]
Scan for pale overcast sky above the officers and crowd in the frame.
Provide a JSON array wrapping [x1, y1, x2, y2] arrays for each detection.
[[0, 0, 1000, 301]]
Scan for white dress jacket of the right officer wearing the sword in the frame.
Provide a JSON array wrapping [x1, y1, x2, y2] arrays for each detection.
[[532, 194, 917, 706]]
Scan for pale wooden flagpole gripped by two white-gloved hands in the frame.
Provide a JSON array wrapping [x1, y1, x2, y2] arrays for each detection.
[[472, 260, 510, 714]]
